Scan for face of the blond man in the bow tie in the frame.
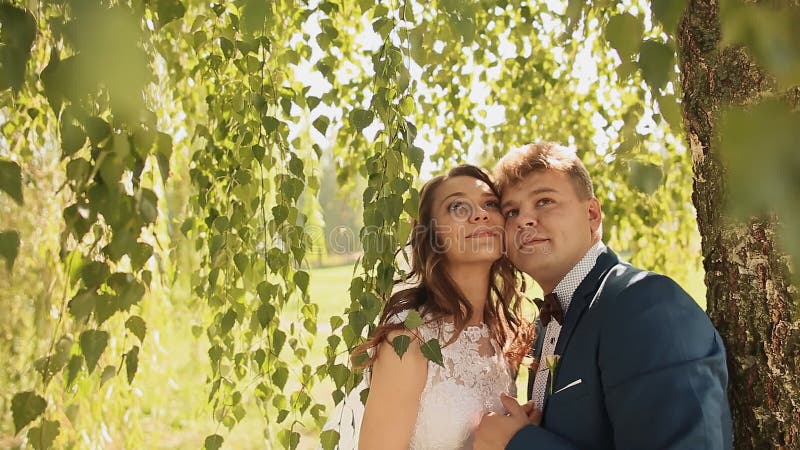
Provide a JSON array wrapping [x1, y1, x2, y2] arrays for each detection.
[[502, 170, 601, 291]]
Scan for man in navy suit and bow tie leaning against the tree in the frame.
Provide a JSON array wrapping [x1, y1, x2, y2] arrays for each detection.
[[475, 143, 732, 450]]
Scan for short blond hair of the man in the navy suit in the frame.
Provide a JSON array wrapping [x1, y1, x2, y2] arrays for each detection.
[[494, 142, 594, 200]]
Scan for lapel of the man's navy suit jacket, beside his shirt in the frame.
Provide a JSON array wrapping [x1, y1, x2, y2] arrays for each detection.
[[544, 247, 619, 405]]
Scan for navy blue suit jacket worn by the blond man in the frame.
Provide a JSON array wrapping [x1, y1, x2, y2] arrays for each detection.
[[506, 249, 732, 450]]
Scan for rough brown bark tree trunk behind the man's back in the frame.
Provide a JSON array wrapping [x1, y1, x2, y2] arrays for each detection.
[[678, 0, 800, 449]]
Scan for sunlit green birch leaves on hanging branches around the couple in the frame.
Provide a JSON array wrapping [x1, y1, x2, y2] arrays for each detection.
[[0, 0, 797, 448]]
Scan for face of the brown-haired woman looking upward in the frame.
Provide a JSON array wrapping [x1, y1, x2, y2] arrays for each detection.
[[432, 176, 504, 264]]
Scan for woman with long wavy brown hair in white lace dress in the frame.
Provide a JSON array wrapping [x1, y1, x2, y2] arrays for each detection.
[[325, 165, 532, 449]]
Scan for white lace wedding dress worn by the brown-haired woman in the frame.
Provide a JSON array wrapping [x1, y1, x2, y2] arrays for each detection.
[[323, 314, 516, 450]]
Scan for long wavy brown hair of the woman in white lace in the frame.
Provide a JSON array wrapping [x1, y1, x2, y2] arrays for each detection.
[[351, 164, 532, 370]]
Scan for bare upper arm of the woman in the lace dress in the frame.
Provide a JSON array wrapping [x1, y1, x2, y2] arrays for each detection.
[[358, 332, 428, 450]]
